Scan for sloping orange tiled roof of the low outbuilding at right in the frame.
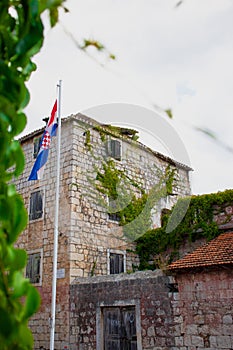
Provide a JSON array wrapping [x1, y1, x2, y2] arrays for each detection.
[[168, 232, 233, 271]]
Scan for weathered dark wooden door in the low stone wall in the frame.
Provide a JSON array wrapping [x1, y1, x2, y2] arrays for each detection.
[[103, 306, 137, 350]]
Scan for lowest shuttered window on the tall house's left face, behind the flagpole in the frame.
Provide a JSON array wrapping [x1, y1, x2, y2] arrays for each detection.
[[26, 252, 41, 284]]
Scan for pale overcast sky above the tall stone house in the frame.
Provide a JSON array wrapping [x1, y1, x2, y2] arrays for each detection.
[[24, 0, 233, 194]]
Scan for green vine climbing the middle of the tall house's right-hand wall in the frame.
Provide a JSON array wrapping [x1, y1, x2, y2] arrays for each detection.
[[93, 159, 176, 241]]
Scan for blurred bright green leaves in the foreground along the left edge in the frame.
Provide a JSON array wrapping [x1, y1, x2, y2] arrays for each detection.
[[0, 0, 63, 350]]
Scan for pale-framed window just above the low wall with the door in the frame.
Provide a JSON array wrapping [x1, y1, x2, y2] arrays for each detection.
[[107, 249, 126, 275]]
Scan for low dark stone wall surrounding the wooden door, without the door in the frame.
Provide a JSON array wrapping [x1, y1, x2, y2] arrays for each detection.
[[70, 270, 177, 350]]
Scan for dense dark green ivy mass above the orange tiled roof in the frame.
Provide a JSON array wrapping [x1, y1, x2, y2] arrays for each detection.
[[136, 190, 233, 269]]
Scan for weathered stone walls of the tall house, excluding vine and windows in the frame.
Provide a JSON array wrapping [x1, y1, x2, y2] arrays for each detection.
[[16, 115, 190, 350]]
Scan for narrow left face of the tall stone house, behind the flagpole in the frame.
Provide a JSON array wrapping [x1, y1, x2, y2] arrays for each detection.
[[16, 121, 72, 350]]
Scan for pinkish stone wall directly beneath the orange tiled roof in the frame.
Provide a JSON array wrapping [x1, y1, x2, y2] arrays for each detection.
[[175, 268, 233, 350]]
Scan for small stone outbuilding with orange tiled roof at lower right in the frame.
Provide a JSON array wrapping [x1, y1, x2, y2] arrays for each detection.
[[169, 231, 233, 350]]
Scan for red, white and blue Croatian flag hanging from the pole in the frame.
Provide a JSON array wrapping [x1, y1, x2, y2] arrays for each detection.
[[28, 101, 57, 181]]
